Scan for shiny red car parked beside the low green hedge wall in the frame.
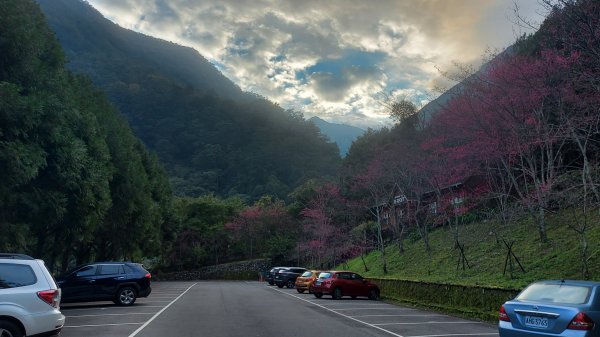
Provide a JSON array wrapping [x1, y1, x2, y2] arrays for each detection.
[[312, 271, 379, 300]]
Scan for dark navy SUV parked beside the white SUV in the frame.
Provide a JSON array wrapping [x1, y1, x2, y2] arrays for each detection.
[[57, 262, 152, 306]]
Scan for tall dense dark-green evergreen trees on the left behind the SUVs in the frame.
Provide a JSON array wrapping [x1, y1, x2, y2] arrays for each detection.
[[0, 0, 174, 270]]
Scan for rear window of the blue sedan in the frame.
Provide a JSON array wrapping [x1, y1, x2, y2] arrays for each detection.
[[516, 283, 591, 304]]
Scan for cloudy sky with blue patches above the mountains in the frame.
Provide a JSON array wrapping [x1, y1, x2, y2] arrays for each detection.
[[88, 0, 546, 128]]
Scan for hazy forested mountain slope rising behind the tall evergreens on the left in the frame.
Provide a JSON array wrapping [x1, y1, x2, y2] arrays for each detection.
[[38, 0, 340, 199]]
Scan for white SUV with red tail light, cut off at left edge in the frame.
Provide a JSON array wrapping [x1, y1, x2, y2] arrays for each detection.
[[0, 254, 65, 337]]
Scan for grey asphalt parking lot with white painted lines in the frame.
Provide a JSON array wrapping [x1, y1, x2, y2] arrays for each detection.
[[61, 281, 498, 337]]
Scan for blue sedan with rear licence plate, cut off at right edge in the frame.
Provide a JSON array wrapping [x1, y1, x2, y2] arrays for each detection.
[[498, 280, 600, 337]]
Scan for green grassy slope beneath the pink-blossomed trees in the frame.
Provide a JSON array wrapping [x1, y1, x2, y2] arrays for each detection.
[[339, 212, 600, 289]]
